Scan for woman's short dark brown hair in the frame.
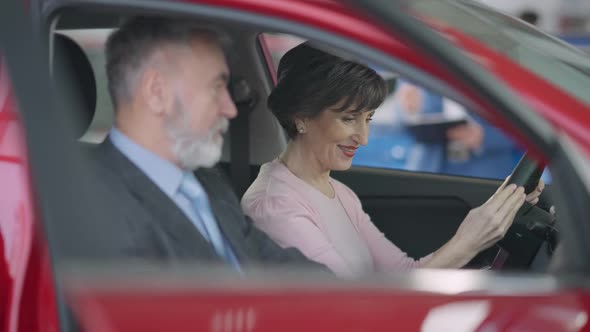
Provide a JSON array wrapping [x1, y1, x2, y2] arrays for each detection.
[[267, 42, 387, 138]]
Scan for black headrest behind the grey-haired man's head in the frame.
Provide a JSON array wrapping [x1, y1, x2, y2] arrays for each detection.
[[53, 33, 96, 138]]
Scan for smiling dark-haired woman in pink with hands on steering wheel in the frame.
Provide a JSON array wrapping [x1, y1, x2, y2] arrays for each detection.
[[242, 43, 542, 278]]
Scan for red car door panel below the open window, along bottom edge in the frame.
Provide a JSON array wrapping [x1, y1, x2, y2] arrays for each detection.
[[66, 287, 590, 332]]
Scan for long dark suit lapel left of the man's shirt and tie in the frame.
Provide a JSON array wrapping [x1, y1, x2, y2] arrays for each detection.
[[100, 139, 220, 260]]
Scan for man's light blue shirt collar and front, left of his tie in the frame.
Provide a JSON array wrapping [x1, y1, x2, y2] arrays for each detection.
[[109, 127, 184, 199]]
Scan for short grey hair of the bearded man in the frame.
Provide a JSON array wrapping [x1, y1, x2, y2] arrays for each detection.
[[105, 16, 222, 109]]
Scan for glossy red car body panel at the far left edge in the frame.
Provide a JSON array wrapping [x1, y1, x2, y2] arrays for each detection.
[[0, 61, 59, 332]]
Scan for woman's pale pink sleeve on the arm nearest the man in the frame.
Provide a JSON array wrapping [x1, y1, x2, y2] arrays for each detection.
[[250, 197, 354, 278]]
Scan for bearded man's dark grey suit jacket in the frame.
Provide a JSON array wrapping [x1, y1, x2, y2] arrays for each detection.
[[59, 139, 324, 269]]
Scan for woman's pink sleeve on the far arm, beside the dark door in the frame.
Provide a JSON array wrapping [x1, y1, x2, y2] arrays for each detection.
[[346, 187, 432, 272]]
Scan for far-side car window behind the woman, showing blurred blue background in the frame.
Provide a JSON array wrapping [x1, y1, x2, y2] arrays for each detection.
[[260, 33, 551, 183]]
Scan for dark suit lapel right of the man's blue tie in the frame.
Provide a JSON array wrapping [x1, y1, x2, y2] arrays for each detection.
[[195, 169, 249, 262]]
